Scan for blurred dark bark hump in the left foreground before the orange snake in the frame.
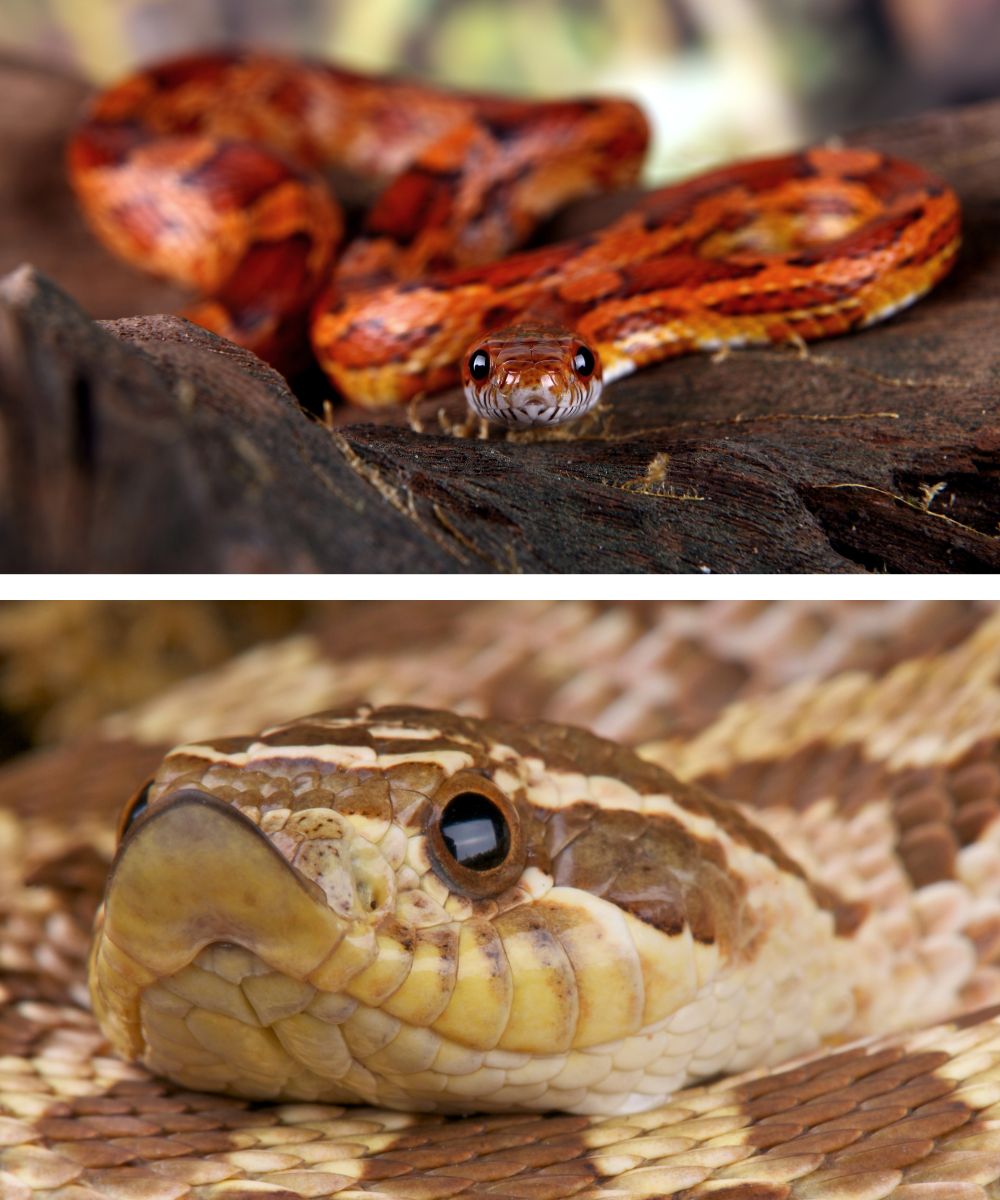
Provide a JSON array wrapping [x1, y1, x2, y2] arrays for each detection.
[[0, 268, 487, 575]]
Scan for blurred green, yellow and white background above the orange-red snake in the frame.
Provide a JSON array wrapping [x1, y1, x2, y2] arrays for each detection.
[[0, 0, 1000, 184]]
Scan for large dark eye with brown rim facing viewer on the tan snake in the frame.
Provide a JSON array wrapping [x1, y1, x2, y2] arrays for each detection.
[[427, 770, 527, 896]]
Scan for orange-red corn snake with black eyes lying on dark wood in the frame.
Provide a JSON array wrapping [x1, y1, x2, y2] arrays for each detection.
[[68, 52, 959, 427]]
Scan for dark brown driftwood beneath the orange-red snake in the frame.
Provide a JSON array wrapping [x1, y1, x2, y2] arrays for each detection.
[[0, 57, 1000, 575]]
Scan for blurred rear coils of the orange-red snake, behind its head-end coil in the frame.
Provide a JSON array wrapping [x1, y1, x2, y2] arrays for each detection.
[[68, 54, 647, 388]]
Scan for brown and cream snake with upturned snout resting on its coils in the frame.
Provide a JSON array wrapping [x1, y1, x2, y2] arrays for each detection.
[[0, 610, 1000, 1200]]
